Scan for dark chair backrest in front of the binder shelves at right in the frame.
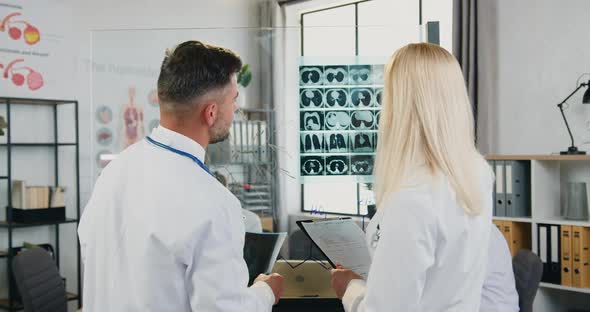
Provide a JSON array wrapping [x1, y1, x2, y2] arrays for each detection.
[[512, 249, 543, 312]]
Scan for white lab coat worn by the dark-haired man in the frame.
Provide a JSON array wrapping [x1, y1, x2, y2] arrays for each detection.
[[78, 126, 274, 312]]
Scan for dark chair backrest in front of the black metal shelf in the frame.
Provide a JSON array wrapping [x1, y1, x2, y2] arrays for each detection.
[[12, 248, 68, 312]]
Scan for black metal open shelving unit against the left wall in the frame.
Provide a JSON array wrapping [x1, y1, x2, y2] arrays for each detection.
[[0, 97, 82, 311]]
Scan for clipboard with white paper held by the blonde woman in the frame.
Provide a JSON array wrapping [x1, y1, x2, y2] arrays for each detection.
[[296, 217, 371, 279]]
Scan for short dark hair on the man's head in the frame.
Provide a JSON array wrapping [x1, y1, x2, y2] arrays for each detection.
[[158, 40, 242, 108]]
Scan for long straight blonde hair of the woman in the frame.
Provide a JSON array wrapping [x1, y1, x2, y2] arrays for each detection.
[[374, 43, 483, 215]]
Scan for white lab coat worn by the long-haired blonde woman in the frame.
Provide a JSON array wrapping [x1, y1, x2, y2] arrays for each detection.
[[342, 162, 493, 312]]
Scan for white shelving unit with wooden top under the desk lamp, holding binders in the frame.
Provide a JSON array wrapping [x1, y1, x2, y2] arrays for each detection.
[[486, 155, 590, 312]]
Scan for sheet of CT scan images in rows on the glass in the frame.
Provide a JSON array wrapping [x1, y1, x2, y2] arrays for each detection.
[[299, 64, 383, 177]]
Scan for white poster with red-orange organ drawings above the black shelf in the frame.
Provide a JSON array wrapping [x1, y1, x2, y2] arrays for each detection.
[[0, 0, 74, 99]]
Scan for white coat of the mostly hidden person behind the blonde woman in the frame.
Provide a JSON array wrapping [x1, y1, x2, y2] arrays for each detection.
[[479, 225, 520, 312]]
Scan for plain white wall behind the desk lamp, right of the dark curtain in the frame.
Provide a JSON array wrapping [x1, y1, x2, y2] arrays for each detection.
[[479, 0, 590, 154]]
